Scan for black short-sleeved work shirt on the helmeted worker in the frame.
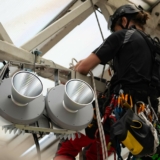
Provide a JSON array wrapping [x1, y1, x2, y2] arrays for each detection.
[[95, 29, 152, 90]]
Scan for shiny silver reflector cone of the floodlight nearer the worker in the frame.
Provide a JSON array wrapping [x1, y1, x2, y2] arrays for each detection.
[[63, 79, 94, 113]]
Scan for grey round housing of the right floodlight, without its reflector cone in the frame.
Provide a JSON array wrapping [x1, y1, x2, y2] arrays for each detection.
[[46, 85, 93, 131]]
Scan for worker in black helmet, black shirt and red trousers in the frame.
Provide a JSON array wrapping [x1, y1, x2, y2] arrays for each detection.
[[54, 4, 158, 160]]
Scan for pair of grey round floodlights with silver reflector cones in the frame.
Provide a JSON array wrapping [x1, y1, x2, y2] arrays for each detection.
[[0, 71, 94, 131]]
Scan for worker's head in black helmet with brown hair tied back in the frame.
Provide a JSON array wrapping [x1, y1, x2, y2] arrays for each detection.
[[108, 4, 149, 32]]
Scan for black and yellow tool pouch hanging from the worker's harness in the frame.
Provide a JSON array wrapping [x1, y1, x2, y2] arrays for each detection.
[[110, 109, 154, 157]]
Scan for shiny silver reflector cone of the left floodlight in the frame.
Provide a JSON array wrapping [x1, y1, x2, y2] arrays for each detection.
[[11, 71, 43, 106]]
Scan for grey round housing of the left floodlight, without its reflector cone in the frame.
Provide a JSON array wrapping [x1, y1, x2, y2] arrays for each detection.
[[0, 78, 45, 124]]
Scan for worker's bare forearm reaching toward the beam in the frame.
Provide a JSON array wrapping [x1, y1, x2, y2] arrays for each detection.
[[75, 53, 101, 75]]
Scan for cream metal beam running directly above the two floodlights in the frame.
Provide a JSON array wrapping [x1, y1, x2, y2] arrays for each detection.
[[0, 38, 105, 92]]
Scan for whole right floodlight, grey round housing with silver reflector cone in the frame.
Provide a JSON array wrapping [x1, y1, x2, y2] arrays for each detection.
[[45, 79, 95, 131]]
